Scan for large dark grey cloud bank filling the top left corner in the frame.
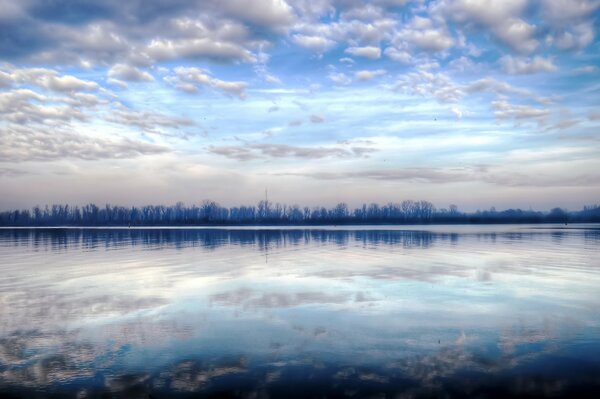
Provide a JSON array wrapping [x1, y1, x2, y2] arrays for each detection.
[[0, 0, 296, 66]]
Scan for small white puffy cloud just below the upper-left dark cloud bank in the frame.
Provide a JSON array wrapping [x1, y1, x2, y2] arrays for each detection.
[[164, 67, 247, 100]]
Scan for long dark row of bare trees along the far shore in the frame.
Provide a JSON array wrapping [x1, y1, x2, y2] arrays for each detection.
[[0, 200, 600, 226]]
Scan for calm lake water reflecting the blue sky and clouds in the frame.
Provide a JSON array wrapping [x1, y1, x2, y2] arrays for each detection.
[[0, 225, 600, 399]]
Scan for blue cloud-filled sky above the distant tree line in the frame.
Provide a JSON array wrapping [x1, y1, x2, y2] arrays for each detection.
[[0, 0, 600, 211]]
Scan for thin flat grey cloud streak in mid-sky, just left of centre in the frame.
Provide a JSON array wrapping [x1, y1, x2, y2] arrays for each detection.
[[208, 144, 376, 161]]
